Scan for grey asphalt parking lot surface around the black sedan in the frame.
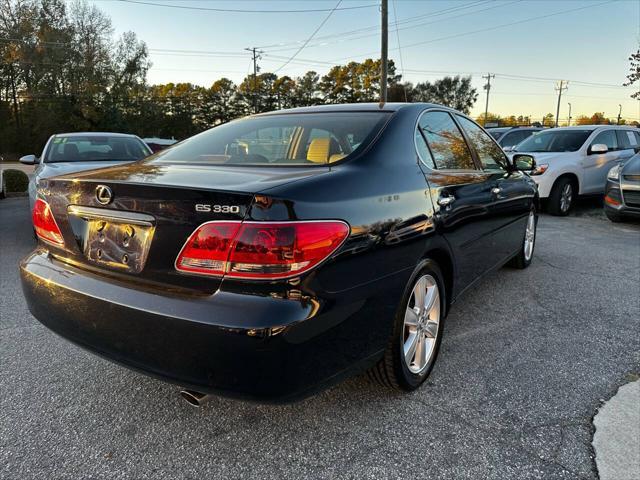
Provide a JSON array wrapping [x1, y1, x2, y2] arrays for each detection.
[[0, 198, 640, 480]]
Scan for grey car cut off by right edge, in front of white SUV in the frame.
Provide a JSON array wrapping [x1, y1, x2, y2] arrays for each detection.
[[604, 154, 640, 222]]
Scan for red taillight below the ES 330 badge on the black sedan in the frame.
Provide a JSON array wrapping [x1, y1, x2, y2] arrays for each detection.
[[176, 220, 349, 279]]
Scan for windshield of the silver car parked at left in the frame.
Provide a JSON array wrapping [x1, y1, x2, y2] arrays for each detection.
[[44, 135, 151, 163]]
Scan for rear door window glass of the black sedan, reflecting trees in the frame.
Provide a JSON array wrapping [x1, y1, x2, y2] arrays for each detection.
[[420, 112, 476, 170]]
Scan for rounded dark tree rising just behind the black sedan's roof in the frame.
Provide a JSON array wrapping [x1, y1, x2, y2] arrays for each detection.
[[412, 75, 478, 113]]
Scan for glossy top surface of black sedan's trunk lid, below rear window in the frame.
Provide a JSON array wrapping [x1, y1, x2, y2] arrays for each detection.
[[59, 161, 330, 193]]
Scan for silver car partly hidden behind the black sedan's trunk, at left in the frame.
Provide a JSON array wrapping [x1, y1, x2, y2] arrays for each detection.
[[20, 132, 153, 210]]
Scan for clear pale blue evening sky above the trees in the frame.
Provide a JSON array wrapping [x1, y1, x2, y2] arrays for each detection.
[[91, 0, 640, 120]]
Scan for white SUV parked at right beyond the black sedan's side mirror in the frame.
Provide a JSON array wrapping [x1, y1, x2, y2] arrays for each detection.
[[513, 125, 640, 215]]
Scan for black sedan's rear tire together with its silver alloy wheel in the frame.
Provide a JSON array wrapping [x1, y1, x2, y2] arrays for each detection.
[[369, 259, 447, 391]]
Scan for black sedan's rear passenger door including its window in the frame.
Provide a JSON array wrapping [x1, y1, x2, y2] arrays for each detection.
[[415, 110, 502, 288]]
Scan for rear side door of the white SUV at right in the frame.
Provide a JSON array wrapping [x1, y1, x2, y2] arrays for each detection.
[[581, 128, 620, 193]]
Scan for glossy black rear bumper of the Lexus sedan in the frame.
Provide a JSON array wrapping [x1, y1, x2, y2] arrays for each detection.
[[20, 250, 392, 402]]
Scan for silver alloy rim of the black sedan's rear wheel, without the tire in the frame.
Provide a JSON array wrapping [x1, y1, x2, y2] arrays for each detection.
[[402, 275, 441, 374]]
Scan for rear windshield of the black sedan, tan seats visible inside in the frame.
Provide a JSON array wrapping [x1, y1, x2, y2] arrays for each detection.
[[152, 112, 389, 166]]
